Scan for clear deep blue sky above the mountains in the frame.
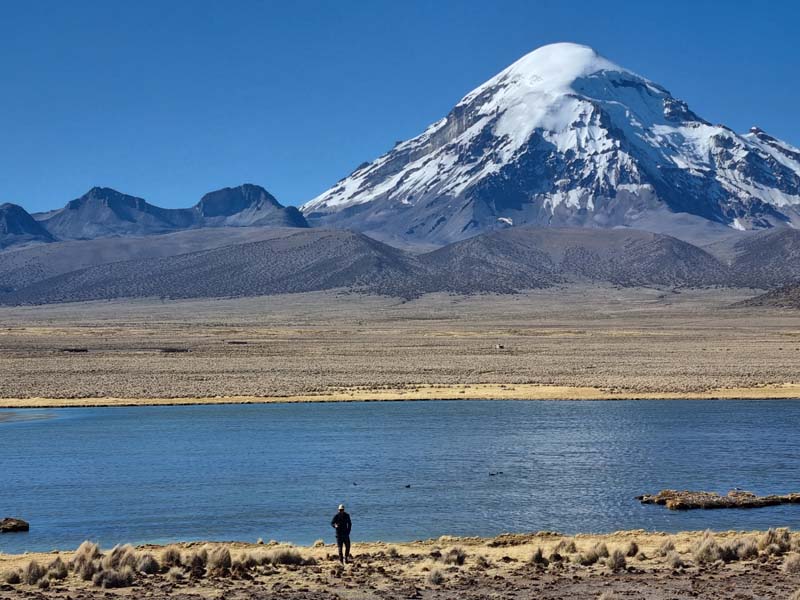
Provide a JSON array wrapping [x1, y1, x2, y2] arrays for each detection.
[[0, 0, 800, 212]]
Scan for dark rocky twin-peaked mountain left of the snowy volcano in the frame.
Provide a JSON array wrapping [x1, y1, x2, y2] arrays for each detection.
[[27, 184, 308, 240]]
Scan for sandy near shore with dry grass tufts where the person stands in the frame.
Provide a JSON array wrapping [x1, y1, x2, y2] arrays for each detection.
[[0, 531, 800, 600]]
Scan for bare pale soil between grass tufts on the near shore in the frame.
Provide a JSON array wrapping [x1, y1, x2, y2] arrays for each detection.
[[0, 531, 800, 600]]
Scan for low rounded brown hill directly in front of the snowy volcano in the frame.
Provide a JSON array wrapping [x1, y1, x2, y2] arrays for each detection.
[[420, 227, 729, 291]]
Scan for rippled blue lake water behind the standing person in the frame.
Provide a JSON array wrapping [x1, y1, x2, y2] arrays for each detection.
[[0, 401, 800, 552]]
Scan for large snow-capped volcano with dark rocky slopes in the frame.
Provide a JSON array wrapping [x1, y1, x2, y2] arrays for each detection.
[[302, 43, 800, 244]]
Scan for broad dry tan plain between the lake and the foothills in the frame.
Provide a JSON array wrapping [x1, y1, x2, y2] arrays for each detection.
[[0, 286, 800, 407]]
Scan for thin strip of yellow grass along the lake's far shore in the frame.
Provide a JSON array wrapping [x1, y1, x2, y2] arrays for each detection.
[[0, 383, 800, 409]]
